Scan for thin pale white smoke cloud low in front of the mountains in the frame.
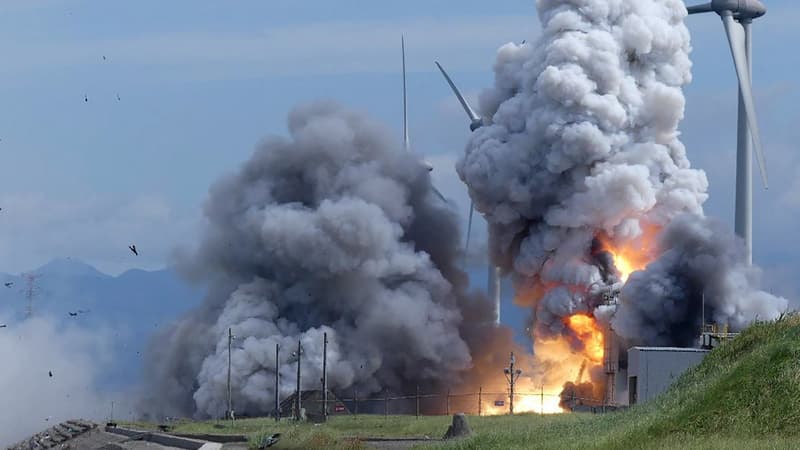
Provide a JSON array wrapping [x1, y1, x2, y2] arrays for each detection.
[[0, 316, 111, 448]]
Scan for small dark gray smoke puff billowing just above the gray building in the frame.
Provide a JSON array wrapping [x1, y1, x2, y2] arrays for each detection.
[[611, 215, 787, 346]]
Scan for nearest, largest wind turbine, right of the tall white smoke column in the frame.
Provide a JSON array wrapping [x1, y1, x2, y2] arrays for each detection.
[[687, 0, 769, 263]]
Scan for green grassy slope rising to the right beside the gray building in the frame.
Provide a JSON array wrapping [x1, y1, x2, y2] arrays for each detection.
[[438, 314, 800, 449]]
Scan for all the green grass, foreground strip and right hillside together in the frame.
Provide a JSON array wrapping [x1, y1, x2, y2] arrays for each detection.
[[125, 315, 800, 450]]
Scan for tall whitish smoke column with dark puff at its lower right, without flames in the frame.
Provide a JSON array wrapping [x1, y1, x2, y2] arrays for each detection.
[[457, 0, 786, 345]]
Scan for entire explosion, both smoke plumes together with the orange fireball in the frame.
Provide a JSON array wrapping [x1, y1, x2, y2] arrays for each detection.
[[143, 0, 787, 417]]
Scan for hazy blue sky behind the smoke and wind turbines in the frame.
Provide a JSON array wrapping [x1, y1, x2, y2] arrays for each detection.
[[0, 0, 800, 306]]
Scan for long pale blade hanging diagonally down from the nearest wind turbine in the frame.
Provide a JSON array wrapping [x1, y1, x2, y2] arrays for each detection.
[[722, 11, 769, 188]]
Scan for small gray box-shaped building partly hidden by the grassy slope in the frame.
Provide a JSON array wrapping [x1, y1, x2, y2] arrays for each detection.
[[628, 347, 708, 405]]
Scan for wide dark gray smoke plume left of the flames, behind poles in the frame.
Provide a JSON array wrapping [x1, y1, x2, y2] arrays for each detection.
[[143, 103, 491, 417]]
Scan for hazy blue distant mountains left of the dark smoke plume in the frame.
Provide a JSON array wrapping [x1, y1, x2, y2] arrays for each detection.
[[0, 258, 204, 388]]
